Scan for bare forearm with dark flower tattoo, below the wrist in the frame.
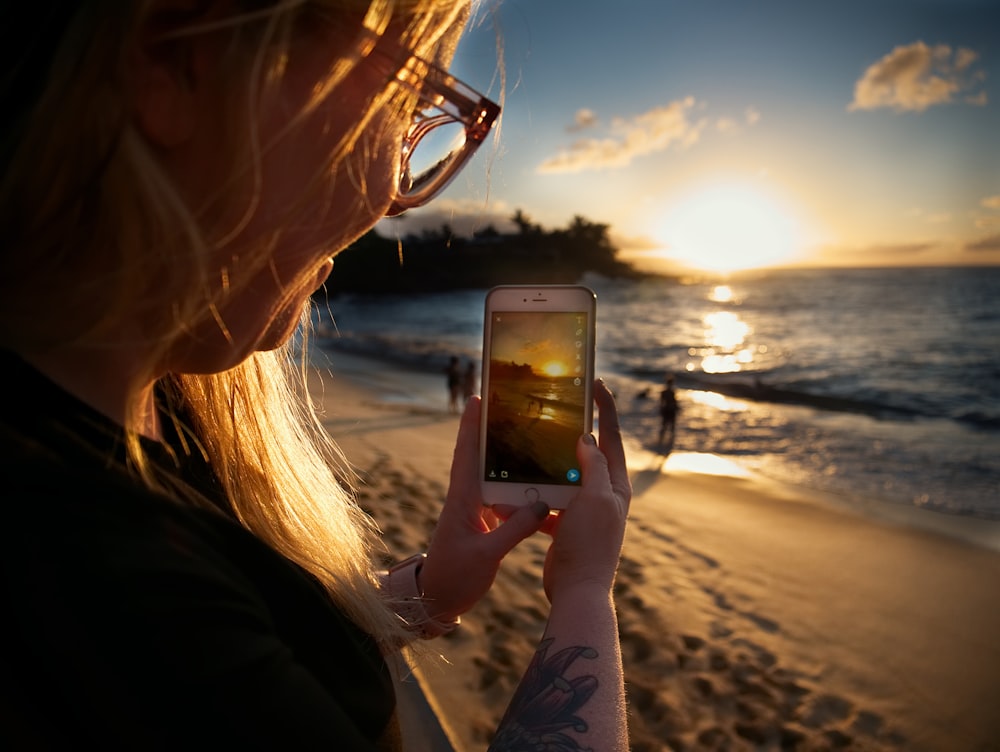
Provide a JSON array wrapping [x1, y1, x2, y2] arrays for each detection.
[[490, 586, 628, 752]]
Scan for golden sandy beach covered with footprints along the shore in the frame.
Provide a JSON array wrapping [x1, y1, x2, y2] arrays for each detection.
[[312, 353, 1000, 752]]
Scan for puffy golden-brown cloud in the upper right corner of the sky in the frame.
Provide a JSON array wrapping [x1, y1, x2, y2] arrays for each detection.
[[848, 42, 986, 112]]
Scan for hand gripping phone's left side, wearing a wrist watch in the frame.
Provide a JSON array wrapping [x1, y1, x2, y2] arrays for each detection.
[[420, 397, 549, 621]]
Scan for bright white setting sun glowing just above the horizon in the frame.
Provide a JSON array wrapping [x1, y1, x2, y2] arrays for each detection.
[[660, 181, 804, 272]]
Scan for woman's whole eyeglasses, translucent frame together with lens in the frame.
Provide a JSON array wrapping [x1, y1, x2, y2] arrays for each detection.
[[378, 56, 500, 217]]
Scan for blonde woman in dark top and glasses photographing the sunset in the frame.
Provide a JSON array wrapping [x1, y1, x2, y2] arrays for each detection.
[[0, 0, 630, 749]]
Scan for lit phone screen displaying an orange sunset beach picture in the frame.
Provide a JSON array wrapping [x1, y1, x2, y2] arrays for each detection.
[[483, 311, 591, 486]]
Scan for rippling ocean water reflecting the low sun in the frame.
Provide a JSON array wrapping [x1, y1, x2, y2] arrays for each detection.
[[314, 267, 1000, 520]]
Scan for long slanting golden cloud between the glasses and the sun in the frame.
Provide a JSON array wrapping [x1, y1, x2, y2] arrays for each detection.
[[536, 97, 705, 174]]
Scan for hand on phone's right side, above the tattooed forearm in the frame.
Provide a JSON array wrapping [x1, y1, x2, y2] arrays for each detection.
[[544, 381, 632, 602]]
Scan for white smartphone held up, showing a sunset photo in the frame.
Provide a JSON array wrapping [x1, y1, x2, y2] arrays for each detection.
[[479, 285, 597, 509]]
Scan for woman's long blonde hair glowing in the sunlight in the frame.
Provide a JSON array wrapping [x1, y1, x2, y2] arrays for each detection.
[[0, 0, 468, 646]]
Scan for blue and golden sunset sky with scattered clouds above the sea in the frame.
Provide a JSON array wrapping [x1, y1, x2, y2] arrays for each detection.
[[379, 0, 1000, 272]]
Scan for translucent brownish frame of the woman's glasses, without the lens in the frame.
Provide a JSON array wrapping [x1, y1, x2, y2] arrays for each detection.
[[376, 55, 500, 217]]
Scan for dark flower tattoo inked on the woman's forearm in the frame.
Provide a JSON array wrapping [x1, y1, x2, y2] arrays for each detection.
[[490, 639, 598, 752]]
